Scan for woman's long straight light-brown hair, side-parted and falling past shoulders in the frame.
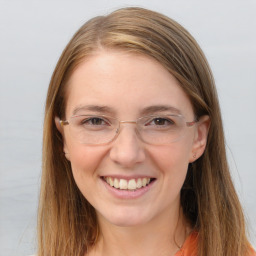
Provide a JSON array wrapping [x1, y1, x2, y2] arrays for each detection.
[[38, 8, 252, 256]]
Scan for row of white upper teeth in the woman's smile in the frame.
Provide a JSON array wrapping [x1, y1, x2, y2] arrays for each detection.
[[105, 177, 150, 190]]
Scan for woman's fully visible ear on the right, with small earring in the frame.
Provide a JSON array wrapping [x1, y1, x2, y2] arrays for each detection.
[[189, 115, 210, 163]]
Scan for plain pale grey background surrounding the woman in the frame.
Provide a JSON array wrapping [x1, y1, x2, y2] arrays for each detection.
[[0, 0, 256, 256]]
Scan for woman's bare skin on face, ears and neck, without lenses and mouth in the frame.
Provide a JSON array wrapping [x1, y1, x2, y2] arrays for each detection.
[[56, 50, 209, 256]]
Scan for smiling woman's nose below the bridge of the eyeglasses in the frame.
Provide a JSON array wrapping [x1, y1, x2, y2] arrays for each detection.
[[110, 124, 145, 168]]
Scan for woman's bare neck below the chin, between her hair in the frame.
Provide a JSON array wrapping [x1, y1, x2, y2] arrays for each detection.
[[89, 206, 190, 256]]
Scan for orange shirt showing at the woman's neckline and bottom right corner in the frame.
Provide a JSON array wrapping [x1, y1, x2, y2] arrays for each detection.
[[174, 231, 256, 256]]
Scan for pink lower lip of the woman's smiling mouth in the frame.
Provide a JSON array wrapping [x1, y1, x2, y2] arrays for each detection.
[[101, 179, 156, 199]]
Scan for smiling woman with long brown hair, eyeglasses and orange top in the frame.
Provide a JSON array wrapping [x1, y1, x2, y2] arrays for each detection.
[[38, 8, 254, 256]]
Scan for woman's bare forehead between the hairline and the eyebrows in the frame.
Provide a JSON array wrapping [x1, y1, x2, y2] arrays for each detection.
[[66, 50, 192, 118]]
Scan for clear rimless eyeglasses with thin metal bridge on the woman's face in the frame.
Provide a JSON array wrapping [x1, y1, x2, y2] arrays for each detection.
[[60, 114, 198, 145]]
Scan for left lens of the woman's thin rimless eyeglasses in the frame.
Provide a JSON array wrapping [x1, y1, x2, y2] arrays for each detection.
[[70, 115, 118, 144]]
